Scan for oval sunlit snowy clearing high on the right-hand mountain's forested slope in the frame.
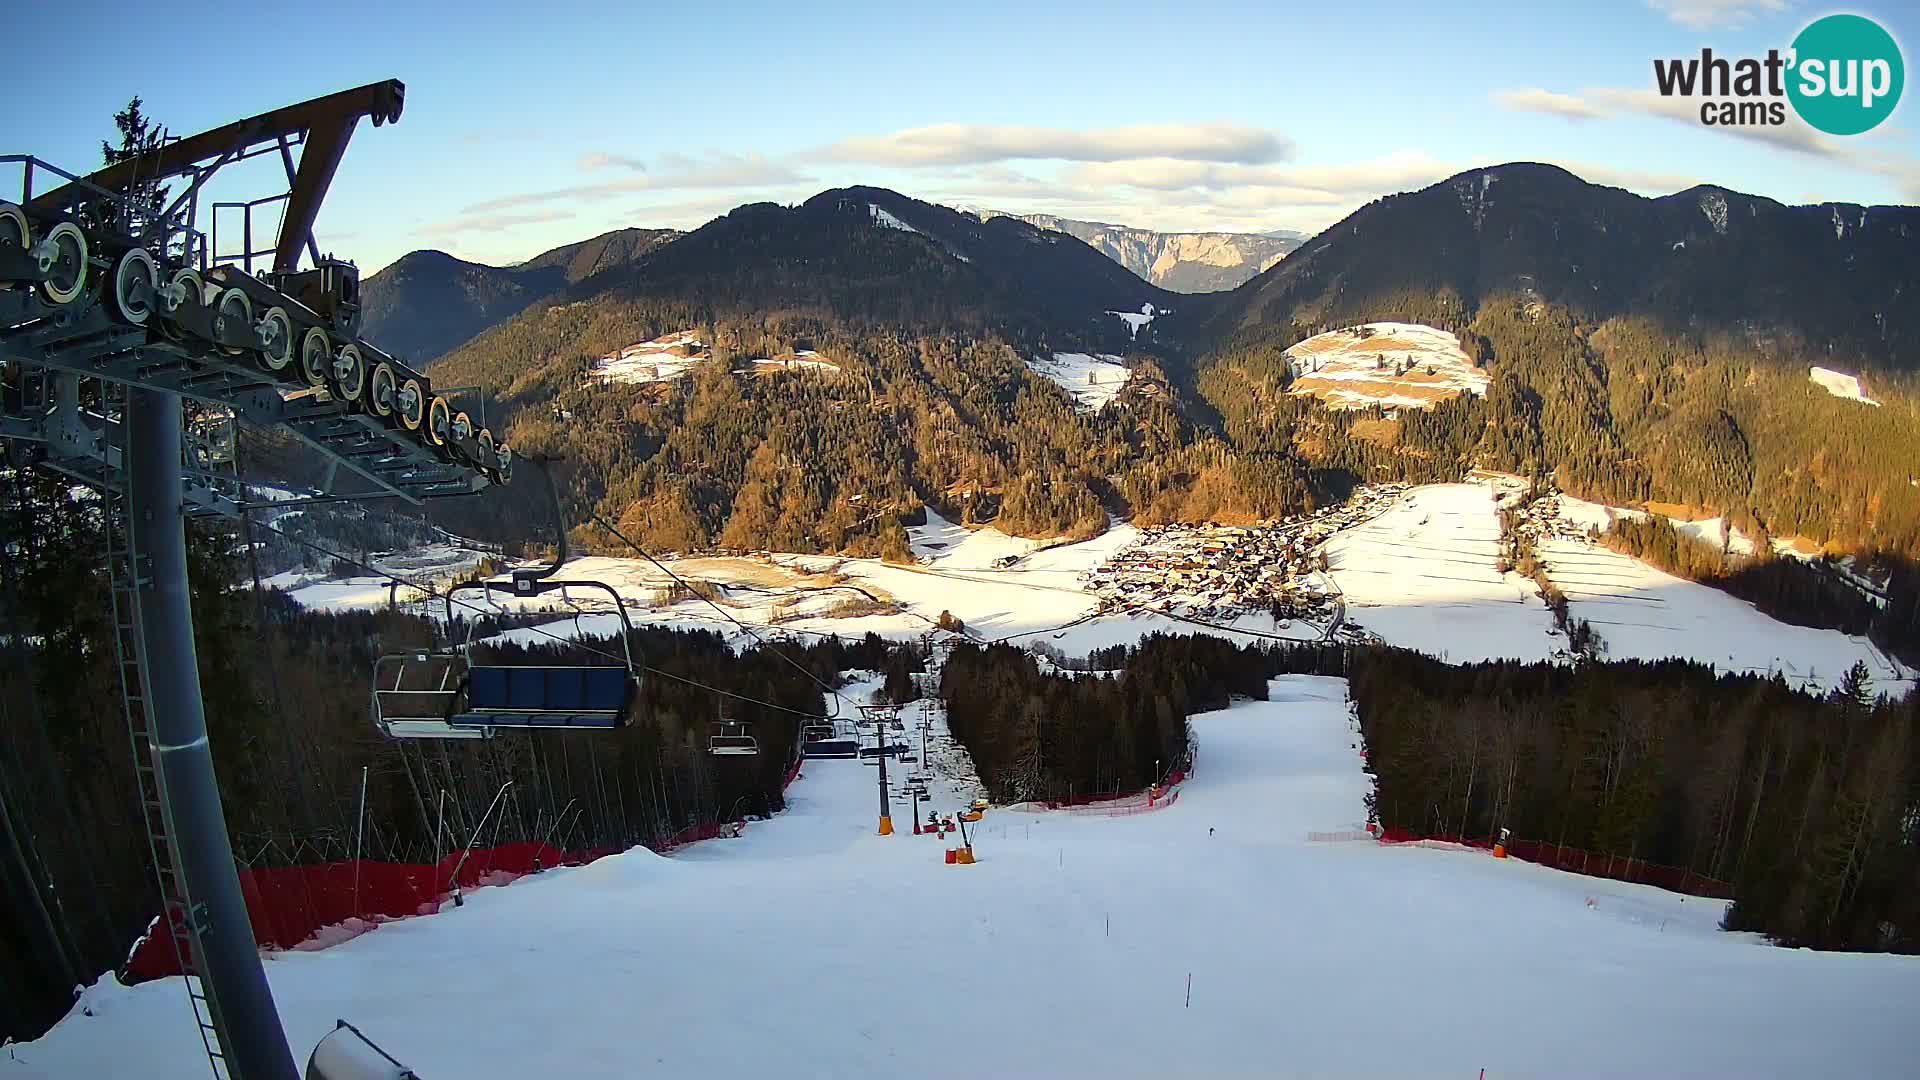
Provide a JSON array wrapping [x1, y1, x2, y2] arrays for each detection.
[[1286, 323, 1490, 409]]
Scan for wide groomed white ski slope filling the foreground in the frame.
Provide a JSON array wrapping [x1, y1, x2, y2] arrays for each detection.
[[0, 676, 1920, 1080]]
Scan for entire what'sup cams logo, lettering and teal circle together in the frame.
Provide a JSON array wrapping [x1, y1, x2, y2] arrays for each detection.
[[1653, 15, 1907, 135]]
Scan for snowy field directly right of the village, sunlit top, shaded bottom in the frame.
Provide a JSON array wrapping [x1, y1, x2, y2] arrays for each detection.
[[1327, 482, 1567, 663]]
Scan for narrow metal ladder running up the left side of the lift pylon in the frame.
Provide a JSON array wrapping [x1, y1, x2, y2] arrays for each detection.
[[102, 438, 232, 1080]]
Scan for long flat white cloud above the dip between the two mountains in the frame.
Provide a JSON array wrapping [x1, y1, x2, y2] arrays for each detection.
[[816, 123, 1292, 167]]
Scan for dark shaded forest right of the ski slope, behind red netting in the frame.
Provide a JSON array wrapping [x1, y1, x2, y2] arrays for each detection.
[[1350, 651, 1920, 953]]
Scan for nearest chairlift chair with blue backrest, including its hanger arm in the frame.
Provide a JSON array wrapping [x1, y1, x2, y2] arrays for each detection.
[[372, 457, 639, 738]]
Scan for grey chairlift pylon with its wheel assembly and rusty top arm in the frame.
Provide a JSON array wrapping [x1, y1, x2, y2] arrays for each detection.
[[0, 79, 513, 1080]]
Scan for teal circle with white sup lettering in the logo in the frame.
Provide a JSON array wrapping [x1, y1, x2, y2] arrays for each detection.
[[1788, 15, 1907, 135]]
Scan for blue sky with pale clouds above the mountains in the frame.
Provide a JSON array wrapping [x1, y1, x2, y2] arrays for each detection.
[[0, 0, 1920, 269]]
